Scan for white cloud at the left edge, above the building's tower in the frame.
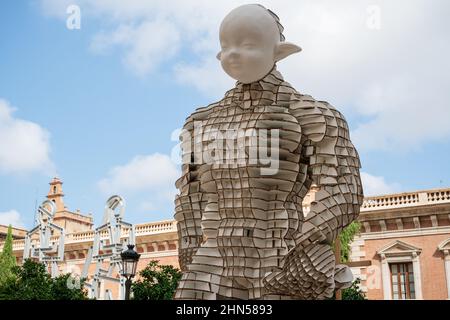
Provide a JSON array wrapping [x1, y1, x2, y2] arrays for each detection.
[[0, 99, 53, 174]]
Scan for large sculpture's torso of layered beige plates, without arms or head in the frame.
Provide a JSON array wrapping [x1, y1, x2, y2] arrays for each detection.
[[183, 70, 309, 296]]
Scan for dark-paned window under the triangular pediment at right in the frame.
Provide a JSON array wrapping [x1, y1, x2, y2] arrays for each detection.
[[389, 262, 416, 300]]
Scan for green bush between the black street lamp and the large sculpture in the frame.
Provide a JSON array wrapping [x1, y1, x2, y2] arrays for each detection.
[[132, 260, 181, 300]]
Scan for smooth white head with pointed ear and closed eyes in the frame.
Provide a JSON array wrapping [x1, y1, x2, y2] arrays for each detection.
[[217, 4, 301, 83]]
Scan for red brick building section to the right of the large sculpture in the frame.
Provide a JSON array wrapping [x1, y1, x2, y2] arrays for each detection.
[[351, 189, 450, 300]]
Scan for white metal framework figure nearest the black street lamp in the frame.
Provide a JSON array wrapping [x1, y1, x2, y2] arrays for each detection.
[[81, 196, 135, 300]]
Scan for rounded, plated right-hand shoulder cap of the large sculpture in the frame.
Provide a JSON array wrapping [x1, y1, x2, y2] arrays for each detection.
[[289, 93, 349, 142]]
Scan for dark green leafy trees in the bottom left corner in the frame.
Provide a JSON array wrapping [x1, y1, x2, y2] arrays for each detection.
[[0, 259, 87, 300]]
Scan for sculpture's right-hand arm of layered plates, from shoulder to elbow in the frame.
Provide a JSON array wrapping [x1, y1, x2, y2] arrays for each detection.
[[295, 98, 363, 247]]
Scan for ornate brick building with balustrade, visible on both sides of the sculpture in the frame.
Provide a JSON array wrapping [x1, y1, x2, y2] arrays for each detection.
[[0, 179, 450, 299]]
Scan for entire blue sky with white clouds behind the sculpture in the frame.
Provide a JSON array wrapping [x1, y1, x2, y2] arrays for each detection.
[[0, 0, 450, 229]]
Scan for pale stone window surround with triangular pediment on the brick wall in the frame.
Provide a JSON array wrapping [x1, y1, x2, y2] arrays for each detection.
[[377, 240, 423, 300]]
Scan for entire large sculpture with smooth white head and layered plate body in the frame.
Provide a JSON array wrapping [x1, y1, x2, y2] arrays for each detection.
[[175, 5, 363, 299]]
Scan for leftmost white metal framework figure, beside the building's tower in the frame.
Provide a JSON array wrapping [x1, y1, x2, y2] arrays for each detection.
[[23, 200, 65, 278]]
